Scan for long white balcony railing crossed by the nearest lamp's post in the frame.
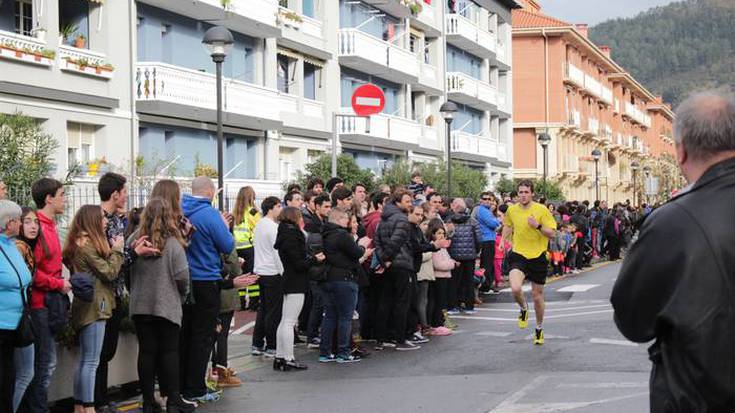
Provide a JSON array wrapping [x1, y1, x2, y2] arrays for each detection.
[[135, 62, 282, 120]]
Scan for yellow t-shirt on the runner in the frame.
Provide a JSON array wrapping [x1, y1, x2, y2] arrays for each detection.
[[503, 202, 556, 259]]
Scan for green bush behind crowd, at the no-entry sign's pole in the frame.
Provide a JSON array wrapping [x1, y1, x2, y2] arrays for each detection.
[[292, 153, 375, 192]]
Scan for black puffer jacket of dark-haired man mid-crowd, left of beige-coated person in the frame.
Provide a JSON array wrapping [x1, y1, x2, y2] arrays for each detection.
[[374, 204, 414, 271]]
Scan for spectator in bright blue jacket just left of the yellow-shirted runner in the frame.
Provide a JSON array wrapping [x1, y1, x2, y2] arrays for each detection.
[[477, 192, 502, 294]]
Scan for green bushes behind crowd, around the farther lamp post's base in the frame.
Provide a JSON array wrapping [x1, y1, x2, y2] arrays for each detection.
[[378, 161, 488, 199]]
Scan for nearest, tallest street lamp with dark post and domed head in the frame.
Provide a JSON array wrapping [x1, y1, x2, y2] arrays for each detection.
[[202, 26, 235, 211]]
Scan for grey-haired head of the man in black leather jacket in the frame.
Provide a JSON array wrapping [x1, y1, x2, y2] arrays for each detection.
[[674, 92, 735, 161]]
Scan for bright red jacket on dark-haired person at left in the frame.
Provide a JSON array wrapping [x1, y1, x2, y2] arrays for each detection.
[[31, 211, 64, 309]]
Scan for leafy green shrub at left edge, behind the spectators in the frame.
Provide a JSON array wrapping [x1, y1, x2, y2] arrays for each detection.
[[0, 112, 59, 205]]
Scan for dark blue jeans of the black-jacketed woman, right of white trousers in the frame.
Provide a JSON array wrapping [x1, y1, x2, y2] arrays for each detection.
[[319, 281, 357, 357]]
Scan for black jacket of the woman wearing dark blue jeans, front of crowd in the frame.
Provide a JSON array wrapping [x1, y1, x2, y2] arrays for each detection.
[[322, 222, 365, 282]]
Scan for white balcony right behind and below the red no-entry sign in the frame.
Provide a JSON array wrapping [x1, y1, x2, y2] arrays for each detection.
[[337, 108, 422, 147]]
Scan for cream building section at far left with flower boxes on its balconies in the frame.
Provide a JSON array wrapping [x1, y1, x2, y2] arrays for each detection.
[[0, 0, 135, 177]]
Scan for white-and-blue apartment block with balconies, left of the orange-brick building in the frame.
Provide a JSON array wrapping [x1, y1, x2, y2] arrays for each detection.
[[0, 0, 519, 193]]
